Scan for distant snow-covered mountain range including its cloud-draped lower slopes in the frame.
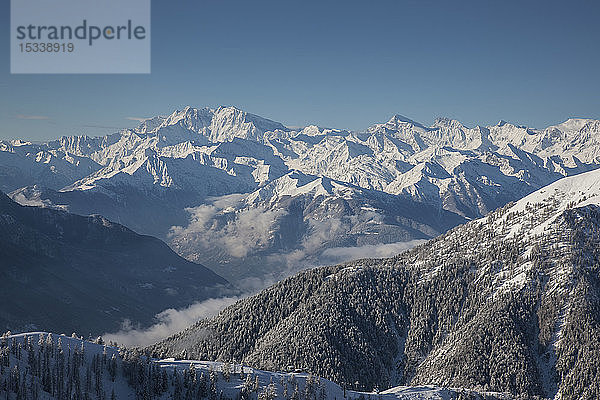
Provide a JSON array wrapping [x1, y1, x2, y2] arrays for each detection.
[[0, 107, 600, 279]]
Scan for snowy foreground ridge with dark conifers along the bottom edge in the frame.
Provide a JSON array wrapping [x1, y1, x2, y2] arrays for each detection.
[[0, 332, 509, 400]]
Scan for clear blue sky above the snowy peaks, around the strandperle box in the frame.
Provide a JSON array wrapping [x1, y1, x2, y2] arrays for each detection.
[[0, 0, 600, 140]]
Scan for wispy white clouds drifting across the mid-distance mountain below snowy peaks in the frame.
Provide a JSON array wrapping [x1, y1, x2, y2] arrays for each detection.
[[169, 195, 432, 278]]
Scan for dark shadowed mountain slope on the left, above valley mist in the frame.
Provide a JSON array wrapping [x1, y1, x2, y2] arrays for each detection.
[[0, 192, 237, 337]]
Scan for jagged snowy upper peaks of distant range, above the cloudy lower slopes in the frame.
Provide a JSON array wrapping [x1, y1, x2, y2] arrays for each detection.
[[0, 106, 600, 255]]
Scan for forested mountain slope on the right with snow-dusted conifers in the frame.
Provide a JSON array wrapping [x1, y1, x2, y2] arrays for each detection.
[[150, 170, 600, 399]]
